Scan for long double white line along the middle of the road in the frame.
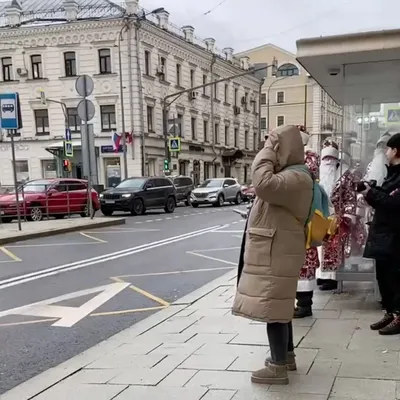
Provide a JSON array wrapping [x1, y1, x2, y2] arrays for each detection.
[[0, 226, 217, 290]]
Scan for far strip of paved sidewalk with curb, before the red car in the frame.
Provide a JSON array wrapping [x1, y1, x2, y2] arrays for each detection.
[[0, 217, 125, 245]]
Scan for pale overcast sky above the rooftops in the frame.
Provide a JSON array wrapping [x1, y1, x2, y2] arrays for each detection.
[[139, 0, 400, 52]]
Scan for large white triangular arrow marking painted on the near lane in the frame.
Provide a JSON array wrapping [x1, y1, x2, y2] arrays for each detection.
[[0, 282, 130, 328]]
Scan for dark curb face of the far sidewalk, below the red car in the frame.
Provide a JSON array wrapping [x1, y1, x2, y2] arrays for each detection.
[[0, 218, 126, 246]]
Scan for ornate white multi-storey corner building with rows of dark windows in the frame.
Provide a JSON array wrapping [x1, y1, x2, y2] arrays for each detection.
[[0, 0, 260, 186]]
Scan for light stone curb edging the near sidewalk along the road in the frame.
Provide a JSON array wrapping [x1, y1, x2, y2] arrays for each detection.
[[0, 268, 236, 400]]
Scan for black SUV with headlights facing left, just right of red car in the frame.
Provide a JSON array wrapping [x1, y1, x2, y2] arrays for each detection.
[[99, 177, 176, 215]]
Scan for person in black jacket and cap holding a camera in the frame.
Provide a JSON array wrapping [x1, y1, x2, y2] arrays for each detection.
[[362, 133, 400, 335]]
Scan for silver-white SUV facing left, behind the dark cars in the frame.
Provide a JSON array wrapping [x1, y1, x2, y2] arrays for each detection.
[[190, 178, 243, 208]]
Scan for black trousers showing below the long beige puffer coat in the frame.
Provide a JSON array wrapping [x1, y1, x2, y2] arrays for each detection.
[[267, 322, 294, 365]]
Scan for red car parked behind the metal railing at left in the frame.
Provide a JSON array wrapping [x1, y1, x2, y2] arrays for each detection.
[[0, 178, 100, 222]]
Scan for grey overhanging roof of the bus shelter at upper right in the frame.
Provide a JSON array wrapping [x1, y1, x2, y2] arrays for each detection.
[[297, 29, 400, 105]]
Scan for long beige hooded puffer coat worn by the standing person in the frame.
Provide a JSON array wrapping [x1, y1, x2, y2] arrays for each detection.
[[232, 126, 313, 323]]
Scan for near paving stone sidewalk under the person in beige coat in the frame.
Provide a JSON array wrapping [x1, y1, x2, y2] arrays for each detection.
[[1, 272, 400, 400]]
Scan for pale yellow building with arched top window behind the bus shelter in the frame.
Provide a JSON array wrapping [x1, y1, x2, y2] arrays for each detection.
[[237, 44, 356, 149]]
